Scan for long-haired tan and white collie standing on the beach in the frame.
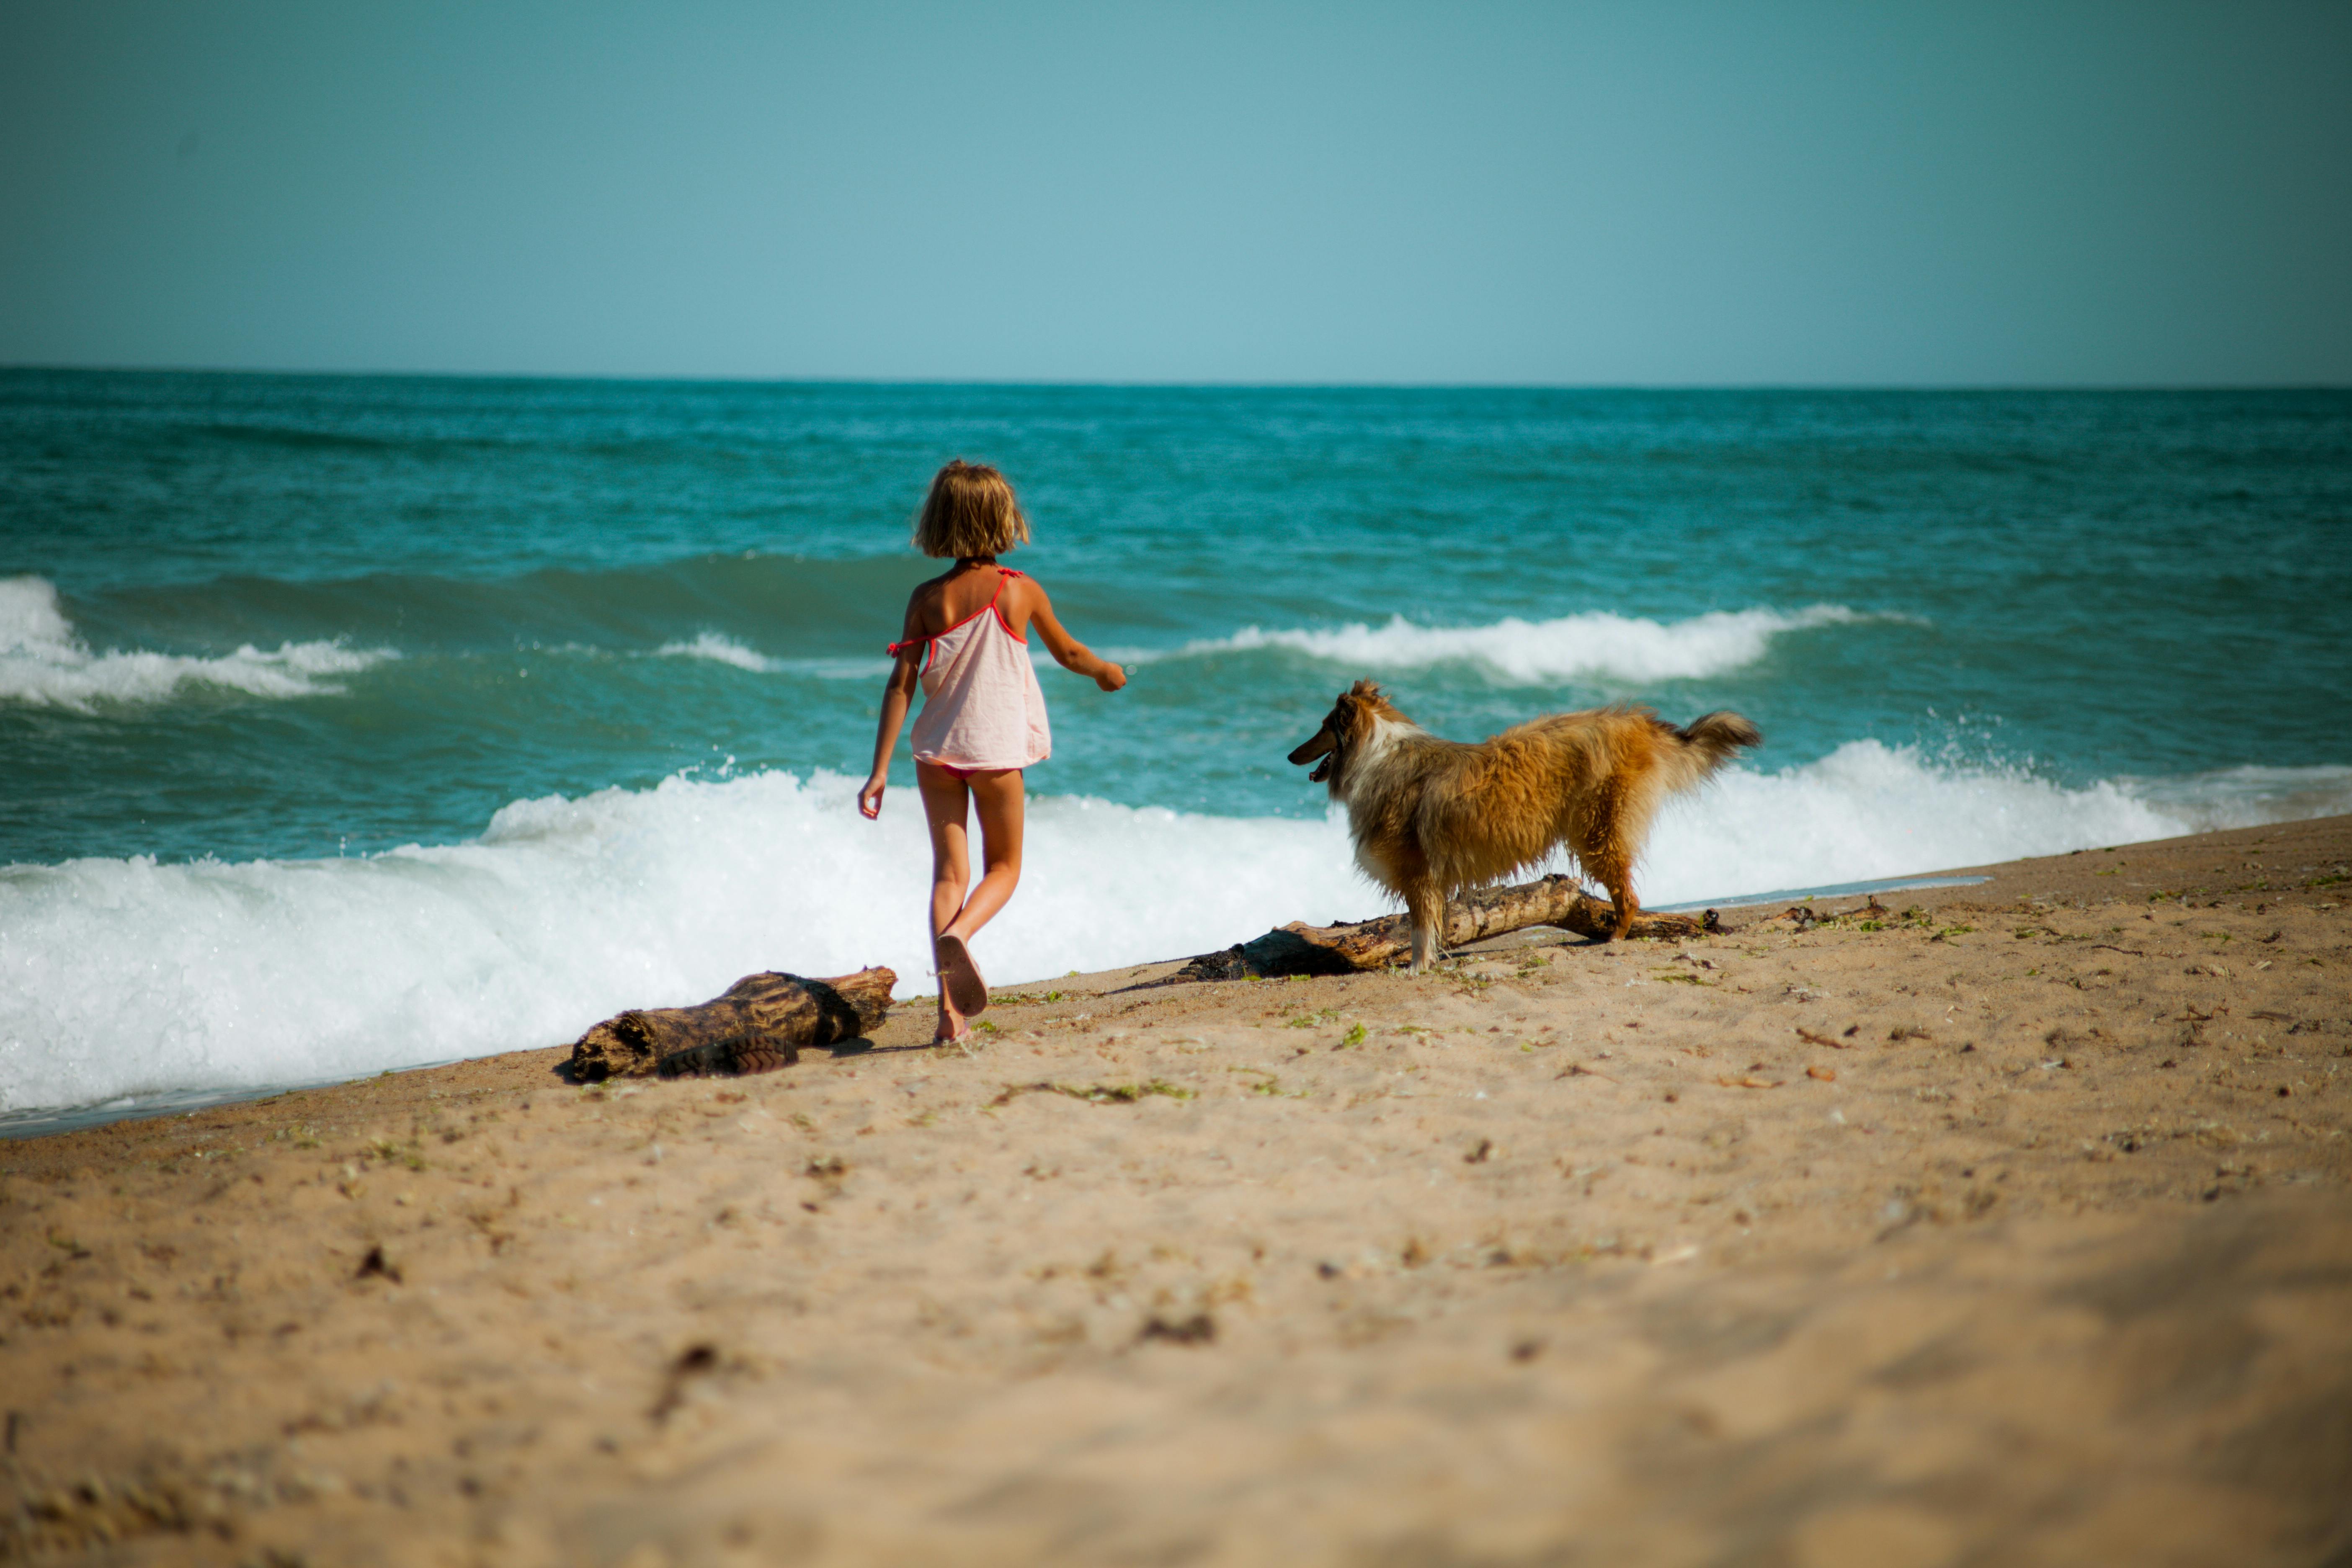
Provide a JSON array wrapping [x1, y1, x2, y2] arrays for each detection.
[[1291, 679, 1764, 973]]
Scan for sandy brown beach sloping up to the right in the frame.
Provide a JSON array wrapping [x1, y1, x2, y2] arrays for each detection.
[[0, 818, 2352, 1568]]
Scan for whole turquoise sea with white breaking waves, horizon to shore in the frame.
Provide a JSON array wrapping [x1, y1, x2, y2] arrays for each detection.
[[0, 369, 2352, 1131]]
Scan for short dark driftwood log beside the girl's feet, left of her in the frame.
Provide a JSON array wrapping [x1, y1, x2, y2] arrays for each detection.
[[572, 969, 898, 1084]]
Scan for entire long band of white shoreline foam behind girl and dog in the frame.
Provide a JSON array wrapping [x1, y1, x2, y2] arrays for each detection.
[[0, 740, 2352, 1109]]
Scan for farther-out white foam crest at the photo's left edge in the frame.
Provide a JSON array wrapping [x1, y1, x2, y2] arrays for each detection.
[[0, 576, 397, 712]]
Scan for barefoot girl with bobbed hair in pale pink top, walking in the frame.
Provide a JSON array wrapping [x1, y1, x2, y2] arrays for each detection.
[[859, 459, 1127, 1044]]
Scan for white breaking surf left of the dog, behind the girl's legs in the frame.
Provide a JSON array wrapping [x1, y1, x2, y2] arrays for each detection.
[[0, 774, 1364, 1109]]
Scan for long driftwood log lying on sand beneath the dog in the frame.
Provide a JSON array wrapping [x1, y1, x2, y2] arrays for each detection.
[[1176, 874, 1719, 980]]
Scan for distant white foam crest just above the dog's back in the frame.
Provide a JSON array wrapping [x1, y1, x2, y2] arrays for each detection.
[[1162, 604, 1875, 684]]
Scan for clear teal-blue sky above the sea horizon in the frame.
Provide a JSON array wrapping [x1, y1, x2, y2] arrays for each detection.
[[0, 0, 2352, 386]]
